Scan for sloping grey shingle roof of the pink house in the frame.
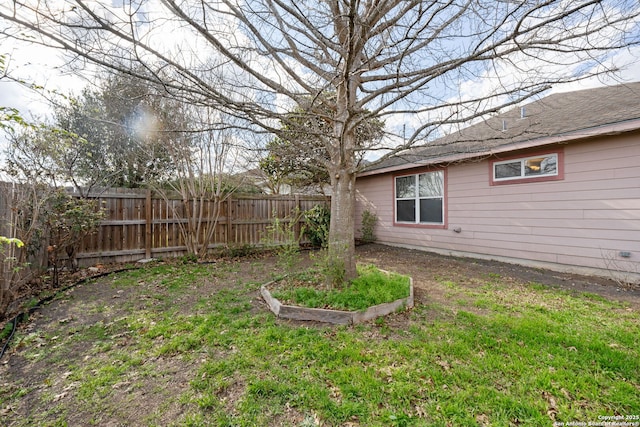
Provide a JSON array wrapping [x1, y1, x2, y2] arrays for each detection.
[[360, 82, 640, 176]]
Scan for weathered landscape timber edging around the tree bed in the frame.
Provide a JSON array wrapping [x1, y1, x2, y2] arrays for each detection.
[[260, 270, 413, 325]]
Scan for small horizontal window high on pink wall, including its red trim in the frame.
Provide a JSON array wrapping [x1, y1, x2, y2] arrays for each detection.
[[491, 152, 562, 184]]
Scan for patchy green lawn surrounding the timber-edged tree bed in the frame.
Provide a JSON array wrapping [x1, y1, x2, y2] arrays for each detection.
[[0, 249, 640, 426]]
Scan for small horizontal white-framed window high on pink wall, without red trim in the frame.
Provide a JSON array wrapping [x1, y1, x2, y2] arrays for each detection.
[[493, 153, 558, 181]]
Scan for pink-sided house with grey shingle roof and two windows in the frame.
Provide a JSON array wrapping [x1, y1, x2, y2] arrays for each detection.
[[356, 83, 640, 282]]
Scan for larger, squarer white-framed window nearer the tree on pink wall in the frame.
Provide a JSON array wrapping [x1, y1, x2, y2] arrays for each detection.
[[395, 171, 444, 225]]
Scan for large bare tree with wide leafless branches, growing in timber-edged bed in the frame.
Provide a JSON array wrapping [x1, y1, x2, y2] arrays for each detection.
[[0, 0, 640, 284]]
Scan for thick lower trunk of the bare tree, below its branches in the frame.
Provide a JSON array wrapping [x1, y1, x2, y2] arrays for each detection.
[[327, 168, 357, 286]]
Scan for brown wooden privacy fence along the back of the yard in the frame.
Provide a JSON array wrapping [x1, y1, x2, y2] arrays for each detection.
[[77, 189, 329, 265]]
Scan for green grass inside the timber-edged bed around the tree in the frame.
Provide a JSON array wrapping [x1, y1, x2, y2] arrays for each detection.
[[273, 265, 409, 311]]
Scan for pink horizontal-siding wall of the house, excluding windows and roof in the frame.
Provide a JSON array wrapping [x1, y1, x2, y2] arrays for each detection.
[[356, 132, 640, 281]]
